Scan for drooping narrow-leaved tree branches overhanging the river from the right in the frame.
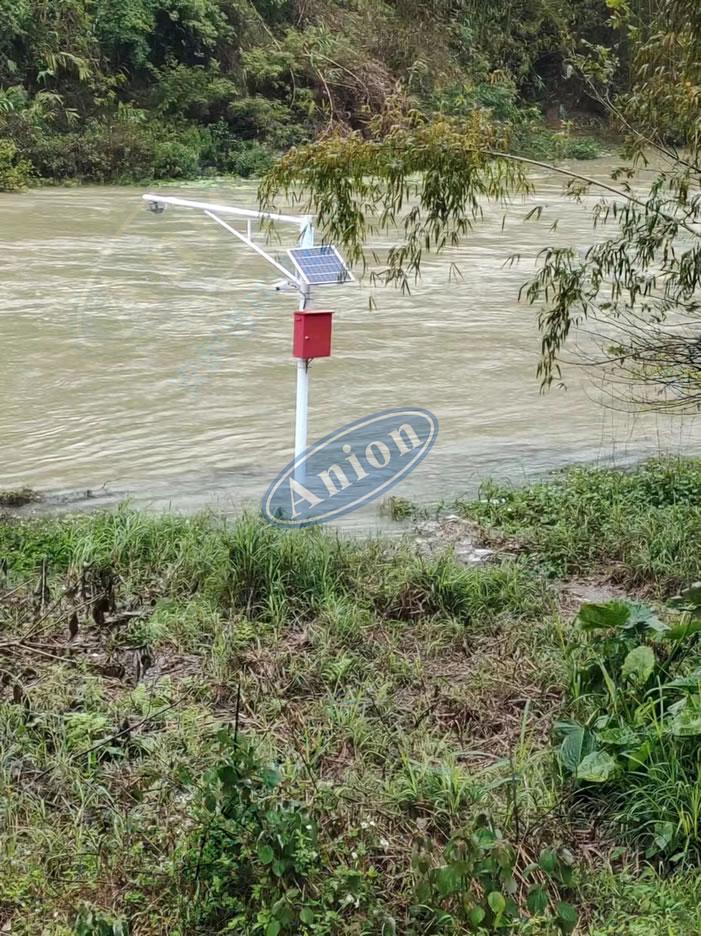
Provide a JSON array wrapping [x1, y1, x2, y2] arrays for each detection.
[[262, 0, 701, 410]]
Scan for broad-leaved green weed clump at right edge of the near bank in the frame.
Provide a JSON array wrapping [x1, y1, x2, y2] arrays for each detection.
[[556, 585, 701, 864]]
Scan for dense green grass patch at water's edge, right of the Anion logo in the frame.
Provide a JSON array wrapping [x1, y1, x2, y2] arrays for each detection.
[[457, 458, 701, 595]]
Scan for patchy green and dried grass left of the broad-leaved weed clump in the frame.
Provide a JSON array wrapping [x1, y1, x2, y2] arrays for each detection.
[[0, 508, 561, 936]]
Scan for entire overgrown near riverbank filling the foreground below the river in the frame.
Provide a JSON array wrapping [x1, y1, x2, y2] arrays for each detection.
[[0, 460, 701, 936]]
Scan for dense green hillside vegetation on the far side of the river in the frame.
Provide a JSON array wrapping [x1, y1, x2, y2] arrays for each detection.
[[0, 0, 612, 190]]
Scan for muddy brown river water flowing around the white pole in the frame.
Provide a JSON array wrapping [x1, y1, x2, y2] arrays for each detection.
[[0, 159, 701, 527]]
